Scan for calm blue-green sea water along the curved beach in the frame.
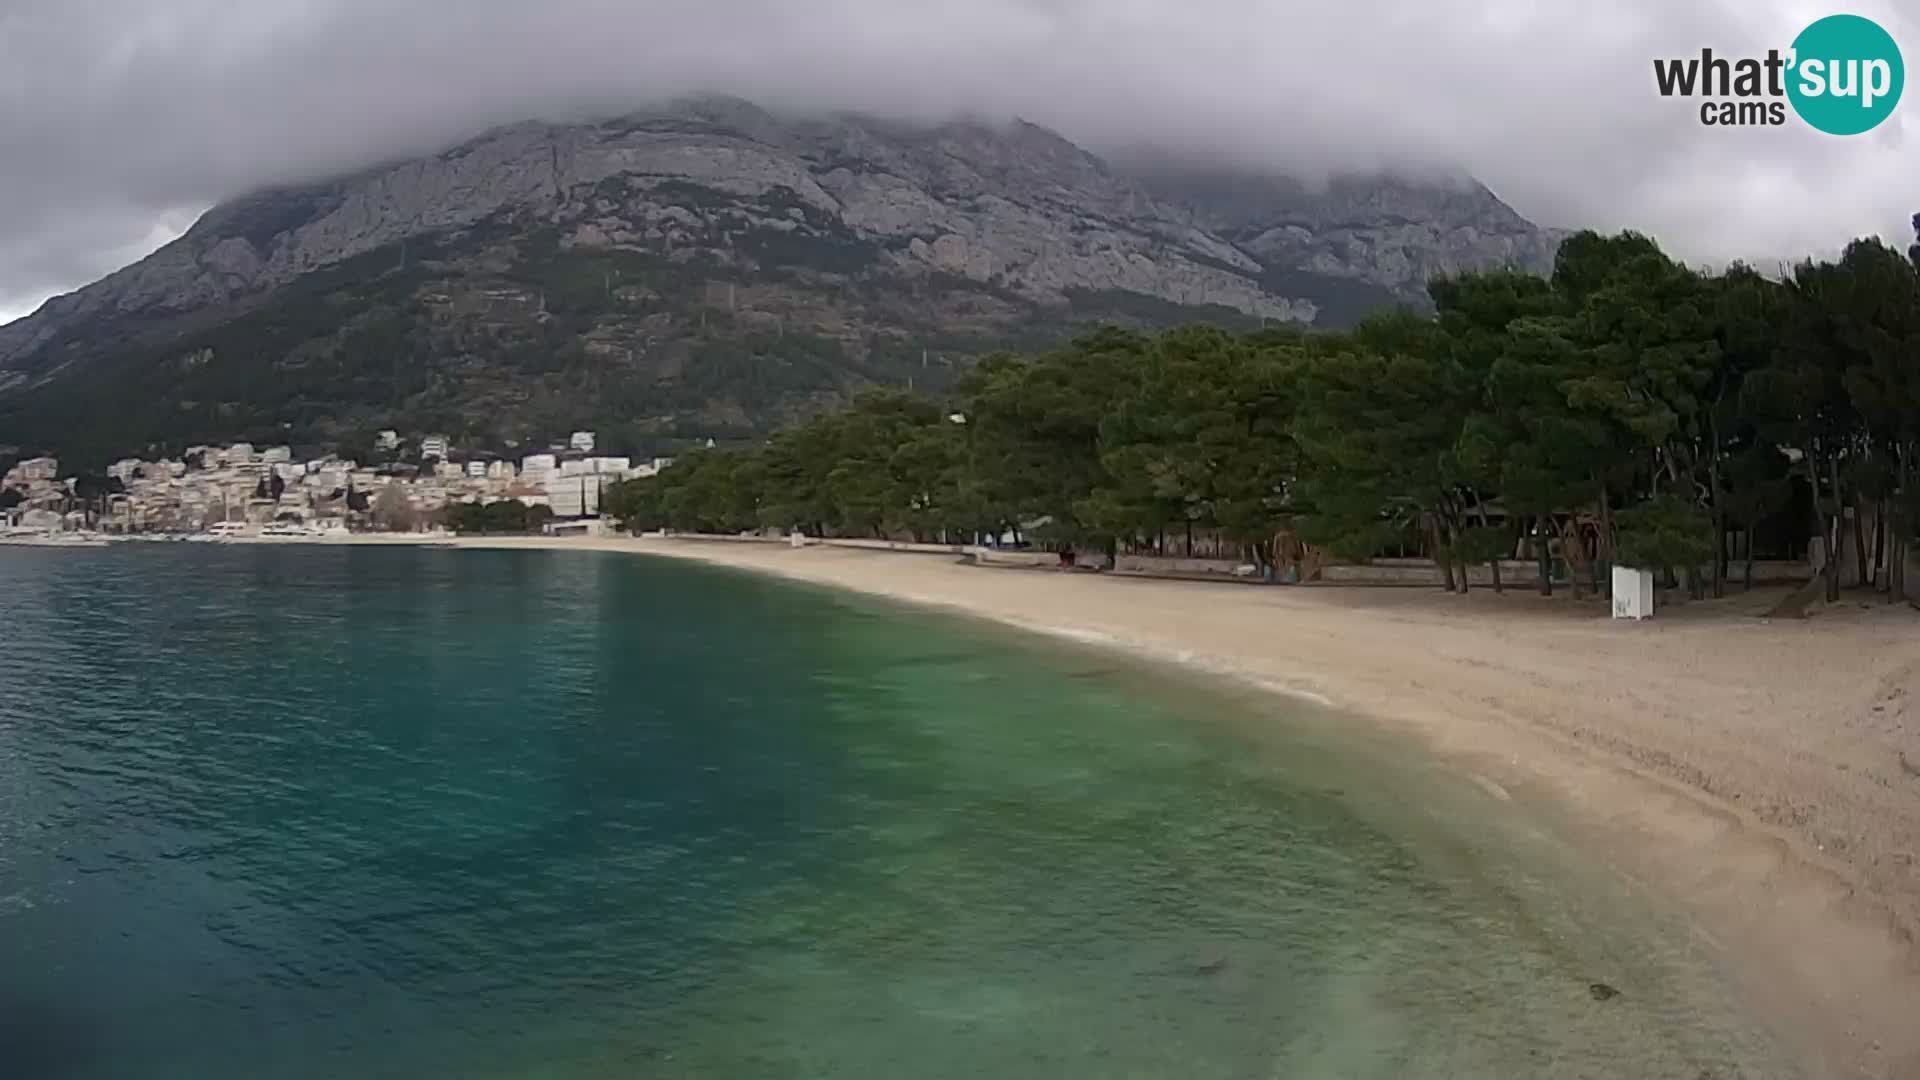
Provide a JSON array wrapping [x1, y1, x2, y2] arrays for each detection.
[[0, 546, 1786, 1080]]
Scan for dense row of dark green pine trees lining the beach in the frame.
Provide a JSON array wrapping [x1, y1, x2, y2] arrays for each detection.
[[609, 217, 1920, 598]]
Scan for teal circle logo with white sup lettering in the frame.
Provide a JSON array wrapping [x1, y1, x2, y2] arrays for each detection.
[[1788, 15, 1907, 135]]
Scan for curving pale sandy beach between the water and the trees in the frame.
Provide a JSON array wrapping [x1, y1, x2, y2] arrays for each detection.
[[30, 536, 1920, 1078]]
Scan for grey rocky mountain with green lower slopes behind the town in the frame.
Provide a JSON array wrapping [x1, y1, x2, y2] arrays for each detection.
[[0, 98, 1555, 454]]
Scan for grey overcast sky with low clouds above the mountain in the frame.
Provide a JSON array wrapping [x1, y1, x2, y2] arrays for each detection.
[[0, 0, 1920, 323]]
